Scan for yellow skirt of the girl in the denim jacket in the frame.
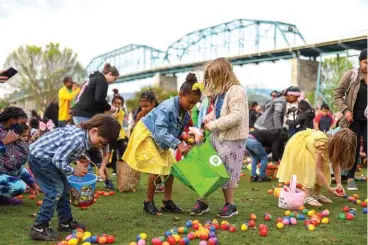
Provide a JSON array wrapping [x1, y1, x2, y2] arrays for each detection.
[[122, 121, 176, 175]]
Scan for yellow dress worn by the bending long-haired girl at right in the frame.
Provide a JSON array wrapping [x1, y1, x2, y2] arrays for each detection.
[[277, 129, 331, 188]]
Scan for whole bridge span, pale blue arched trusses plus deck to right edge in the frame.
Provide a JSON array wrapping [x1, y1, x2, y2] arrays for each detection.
[[86, 19, 367, 85]]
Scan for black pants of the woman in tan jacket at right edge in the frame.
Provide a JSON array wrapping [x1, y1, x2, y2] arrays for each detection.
[[348, 120, 367, 179]]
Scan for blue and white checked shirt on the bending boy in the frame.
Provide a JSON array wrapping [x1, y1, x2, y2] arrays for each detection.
[[29, 125, 91, 174]]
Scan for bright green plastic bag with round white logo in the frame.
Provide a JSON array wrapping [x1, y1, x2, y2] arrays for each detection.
[[171, 135, 229, 198]]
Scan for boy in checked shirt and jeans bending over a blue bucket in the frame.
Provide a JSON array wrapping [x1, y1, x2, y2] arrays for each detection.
[[28, 114, 121, 241]]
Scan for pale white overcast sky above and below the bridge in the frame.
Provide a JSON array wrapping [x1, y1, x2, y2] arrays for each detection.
[[0, 0, 368, 97]]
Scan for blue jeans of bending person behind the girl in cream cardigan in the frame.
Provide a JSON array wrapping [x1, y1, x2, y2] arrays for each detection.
[[246, 137, 268, 177]]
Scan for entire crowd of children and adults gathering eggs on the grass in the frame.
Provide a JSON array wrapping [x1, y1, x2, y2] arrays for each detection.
[[0, 49, 367, 240]]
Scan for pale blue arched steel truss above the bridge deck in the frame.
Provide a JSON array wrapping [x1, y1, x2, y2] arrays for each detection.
[[86, 19, 305, 82]]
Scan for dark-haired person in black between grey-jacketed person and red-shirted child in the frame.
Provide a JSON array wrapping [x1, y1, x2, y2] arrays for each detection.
[[286, 100, 315, 133]]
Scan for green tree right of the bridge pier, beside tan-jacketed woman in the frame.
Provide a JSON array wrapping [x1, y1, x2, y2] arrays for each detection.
[[320, 57, 353, 111]]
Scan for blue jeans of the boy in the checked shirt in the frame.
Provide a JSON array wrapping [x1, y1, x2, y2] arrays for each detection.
[[28, 155, 72, 225]]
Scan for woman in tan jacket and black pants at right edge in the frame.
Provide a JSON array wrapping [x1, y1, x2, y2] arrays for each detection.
[[334, 49, 367, 191]]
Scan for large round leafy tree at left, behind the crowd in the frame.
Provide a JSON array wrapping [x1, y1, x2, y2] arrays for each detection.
[[5, 43, 86, 110]]
